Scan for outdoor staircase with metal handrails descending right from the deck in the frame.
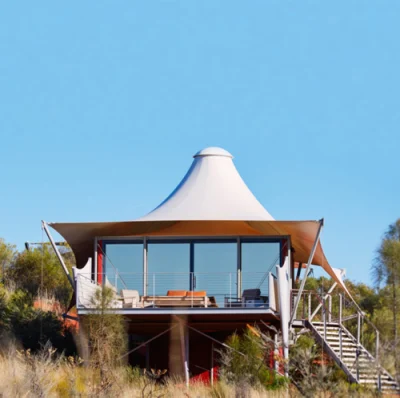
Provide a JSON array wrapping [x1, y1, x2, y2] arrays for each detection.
[[292, 289, 400, 395]]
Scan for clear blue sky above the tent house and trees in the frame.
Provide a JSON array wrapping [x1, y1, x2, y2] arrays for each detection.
[[0, 0, 400, 283]]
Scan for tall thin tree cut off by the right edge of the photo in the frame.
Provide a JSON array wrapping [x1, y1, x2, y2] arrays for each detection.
[[373, 219, 400, 374]]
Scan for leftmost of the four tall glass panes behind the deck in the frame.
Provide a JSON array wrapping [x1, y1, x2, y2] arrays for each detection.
[[104, 242, 143, 294]]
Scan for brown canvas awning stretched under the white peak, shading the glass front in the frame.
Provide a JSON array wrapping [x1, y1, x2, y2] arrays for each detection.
[[49, 220, 343, 285]]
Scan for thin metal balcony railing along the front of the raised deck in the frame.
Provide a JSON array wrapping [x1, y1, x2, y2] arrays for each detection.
[[76, 272, 274, 310]]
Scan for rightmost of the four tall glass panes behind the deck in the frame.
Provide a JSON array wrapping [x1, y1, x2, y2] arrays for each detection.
[[242, 242, 280, 296]]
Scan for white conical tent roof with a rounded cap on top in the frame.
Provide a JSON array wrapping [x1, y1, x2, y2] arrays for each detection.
[[136, 147, 274, 221]]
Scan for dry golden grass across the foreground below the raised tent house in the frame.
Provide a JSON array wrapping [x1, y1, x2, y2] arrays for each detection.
[[0, 348, 293, 398]]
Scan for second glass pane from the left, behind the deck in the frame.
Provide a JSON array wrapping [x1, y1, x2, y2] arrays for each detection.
[[147, 242, 190, 296]]
